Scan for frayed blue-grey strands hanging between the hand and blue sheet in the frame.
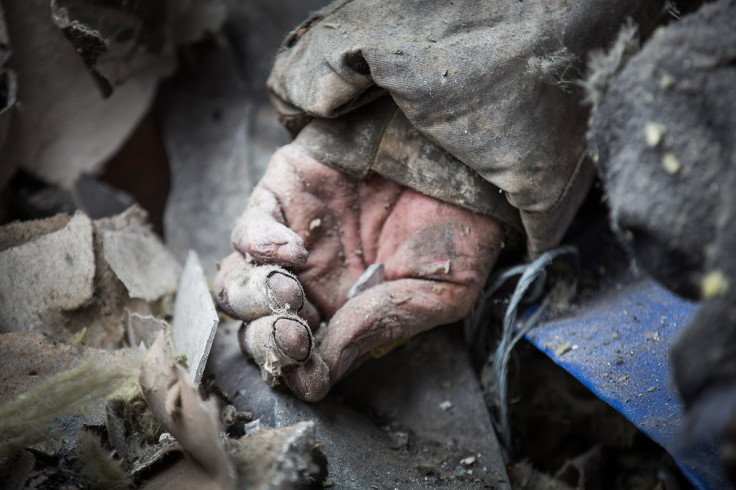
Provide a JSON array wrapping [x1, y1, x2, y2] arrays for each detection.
[[466, 245, 578, 448]]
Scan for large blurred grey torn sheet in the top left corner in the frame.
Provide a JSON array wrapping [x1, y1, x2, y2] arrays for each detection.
[[0, 0, 225, 189]]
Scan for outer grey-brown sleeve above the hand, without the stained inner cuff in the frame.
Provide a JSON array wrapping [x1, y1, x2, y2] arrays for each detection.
[[268, 0, 664, 255]]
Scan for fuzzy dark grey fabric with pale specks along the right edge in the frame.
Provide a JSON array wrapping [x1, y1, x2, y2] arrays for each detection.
[[589, 0, 736, 403]]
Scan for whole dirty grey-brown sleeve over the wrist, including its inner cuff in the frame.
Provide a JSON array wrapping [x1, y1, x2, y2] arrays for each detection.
[[267, 0, 665, 256]]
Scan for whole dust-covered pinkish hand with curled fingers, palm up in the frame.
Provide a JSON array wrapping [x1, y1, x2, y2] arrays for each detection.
[[210, 145, 503, 401]]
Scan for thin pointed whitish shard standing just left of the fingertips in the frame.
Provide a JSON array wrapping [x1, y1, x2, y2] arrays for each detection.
[[171, 251, 219, 383]]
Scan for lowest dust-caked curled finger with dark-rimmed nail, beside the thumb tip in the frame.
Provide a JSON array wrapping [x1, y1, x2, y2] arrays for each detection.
[[238, 314, 314, 386]]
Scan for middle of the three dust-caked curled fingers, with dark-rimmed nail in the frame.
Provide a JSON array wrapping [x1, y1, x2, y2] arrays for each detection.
[[213, 252, 304, 321]]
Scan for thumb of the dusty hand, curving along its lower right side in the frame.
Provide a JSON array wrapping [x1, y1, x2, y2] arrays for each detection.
[[319, 279, 481, 384]]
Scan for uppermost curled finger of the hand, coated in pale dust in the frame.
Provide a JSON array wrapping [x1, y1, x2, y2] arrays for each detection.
[[231, 186, 309, 266]]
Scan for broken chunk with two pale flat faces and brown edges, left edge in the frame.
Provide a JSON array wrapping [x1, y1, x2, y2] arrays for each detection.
[[0, 206, 181, 348]]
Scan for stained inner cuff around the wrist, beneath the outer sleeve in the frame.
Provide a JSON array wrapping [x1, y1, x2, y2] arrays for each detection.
[[294, 97, 522, 245]]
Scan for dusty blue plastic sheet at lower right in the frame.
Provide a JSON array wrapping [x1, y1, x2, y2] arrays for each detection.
[[527, 272, 730, 489]]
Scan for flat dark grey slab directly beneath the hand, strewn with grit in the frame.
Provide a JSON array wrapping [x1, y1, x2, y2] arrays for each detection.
[[208, 322, 510, 489]]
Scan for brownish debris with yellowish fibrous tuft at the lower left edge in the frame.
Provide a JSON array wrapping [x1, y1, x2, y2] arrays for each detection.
[[0, 332, 138, 456]]
